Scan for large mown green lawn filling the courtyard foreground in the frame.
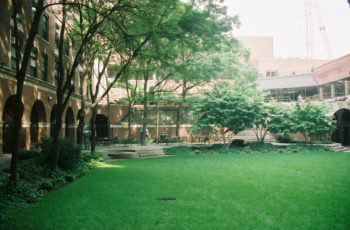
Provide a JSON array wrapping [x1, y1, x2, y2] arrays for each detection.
[[11, 152, 350, 230]]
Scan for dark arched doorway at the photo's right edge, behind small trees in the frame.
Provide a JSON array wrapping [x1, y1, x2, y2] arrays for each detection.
[[332, 109, 350, 145]]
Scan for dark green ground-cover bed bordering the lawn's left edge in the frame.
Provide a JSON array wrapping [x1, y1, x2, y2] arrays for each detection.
[[0, 146, 104, 229]]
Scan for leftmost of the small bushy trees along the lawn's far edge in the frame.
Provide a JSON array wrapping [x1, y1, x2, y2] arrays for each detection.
[[194, 83, 256, 147]]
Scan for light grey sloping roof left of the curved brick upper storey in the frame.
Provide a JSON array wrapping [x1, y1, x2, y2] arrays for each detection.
[[257, 74, 318, 89]]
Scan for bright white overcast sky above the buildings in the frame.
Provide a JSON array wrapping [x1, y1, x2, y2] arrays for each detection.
[[224, 0, 350, 59]]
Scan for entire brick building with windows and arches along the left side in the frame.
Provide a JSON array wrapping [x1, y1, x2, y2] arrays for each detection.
[[0, 0, 92, 155]]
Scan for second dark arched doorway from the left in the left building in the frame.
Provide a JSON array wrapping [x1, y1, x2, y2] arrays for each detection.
[[30, 100, 46, 146]]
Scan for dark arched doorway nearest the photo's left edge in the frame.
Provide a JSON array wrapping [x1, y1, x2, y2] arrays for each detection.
[[2, 95, 16, 153]]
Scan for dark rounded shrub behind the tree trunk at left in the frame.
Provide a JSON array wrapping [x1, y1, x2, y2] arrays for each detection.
[[41, 138, 81, 170]]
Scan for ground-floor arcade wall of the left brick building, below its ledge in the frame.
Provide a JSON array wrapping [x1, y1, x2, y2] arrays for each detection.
[[0, 68, 90, 155]]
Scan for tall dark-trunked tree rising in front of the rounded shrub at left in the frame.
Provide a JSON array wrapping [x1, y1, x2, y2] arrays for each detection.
[[51, 0, 119, 169]]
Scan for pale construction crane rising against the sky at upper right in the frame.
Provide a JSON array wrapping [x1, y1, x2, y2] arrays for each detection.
[[304, 0, 332, 59]]
